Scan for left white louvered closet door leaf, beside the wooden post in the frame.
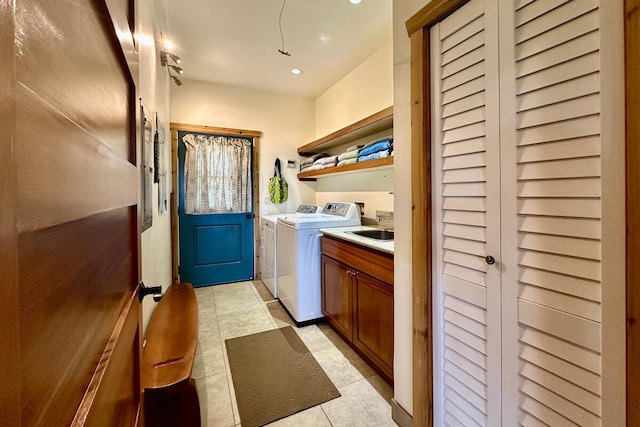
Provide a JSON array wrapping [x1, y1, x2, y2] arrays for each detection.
[[431, 0, 501, 427]]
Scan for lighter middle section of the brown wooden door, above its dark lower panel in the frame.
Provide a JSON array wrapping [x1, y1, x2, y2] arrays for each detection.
[[15, 87, 138, 232]]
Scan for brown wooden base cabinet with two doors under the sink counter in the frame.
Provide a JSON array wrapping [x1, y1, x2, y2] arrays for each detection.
[[321, 236, 393, 383]]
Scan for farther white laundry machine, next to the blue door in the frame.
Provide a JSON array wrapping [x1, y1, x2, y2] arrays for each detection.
[[260, 205, 321, 298]]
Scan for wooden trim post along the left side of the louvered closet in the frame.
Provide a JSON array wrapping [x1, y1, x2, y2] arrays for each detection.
[[406, 0, 468, 426]]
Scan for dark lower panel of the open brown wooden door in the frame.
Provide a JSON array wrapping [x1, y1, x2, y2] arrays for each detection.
[[18, 208, 137, 425]]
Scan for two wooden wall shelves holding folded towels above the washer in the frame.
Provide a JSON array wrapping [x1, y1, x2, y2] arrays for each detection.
[[298, 107, 393, 181]]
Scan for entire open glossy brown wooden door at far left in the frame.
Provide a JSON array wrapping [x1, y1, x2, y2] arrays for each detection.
[[0, 0, 141, 426]]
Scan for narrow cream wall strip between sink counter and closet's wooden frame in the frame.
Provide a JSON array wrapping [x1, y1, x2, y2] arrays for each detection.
[[393, 0, 429, 414]]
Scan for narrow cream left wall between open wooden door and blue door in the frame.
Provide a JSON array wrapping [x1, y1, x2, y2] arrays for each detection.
[[136, 0, 171, 330]]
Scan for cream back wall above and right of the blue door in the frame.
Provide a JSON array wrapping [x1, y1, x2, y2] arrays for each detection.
[[171, 80, 315, 215]]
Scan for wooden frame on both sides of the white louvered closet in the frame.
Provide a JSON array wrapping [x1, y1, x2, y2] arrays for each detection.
[[406, 0, 640, 426]]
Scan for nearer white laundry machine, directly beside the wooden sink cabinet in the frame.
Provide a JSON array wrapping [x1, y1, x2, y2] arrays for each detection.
[[276, 202, 360, 324]]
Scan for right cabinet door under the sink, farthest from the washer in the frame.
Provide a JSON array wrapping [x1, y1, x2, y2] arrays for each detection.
[[353, 272, 393, 381]]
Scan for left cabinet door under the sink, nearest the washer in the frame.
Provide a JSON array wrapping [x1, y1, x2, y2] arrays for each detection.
[[321, 255, 353, 341]]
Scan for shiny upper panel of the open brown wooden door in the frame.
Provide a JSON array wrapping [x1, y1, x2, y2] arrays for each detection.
[[16, 1, 133, 158]]
